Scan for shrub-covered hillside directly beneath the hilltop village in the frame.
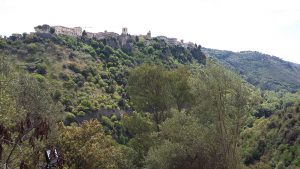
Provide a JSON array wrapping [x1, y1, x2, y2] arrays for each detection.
[[0, 30, 206, 119]]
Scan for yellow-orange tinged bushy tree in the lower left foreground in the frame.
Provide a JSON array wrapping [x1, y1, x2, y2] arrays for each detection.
[[58, 120, 126, 169]]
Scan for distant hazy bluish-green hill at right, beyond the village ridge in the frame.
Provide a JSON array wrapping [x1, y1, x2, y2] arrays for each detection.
[[203, 48, 300, 92]]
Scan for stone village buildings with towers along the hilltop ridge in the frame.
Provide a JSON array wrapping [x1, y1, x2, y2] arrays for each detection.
[[31, 25, 195, 48]]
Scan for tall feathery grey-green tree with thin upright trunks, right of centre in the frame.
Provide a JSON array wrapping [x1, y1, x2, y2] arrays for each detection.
[[193, 63, 256, 169]]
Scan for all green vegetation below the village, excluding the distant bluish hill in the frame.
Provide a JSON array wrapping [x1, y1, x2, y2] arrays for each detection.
[[0, 30, 300, 169]]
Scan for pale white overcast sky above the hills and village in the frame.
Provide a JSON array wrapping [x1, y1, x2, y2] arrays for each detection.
[[0, 0, 300, 63]]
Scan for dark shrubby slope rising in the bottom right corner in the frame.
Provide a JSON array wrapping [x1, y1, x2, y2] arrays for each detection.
[[241, 102, 300, 169]]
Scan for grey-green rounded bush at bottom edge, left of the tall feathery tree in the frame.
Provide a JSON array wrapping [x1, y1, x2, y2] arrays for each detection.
[[146, 112, 209, 169]]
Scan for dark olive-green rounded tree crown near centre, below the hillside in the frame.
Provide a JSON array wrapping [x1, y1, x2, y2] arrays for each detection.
[[128, 65, 172, 130]]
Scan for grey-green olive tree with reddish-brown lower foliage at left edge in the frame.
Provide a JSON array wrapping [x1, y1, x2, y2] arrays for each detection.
[[0, 57, 62, 168]]
